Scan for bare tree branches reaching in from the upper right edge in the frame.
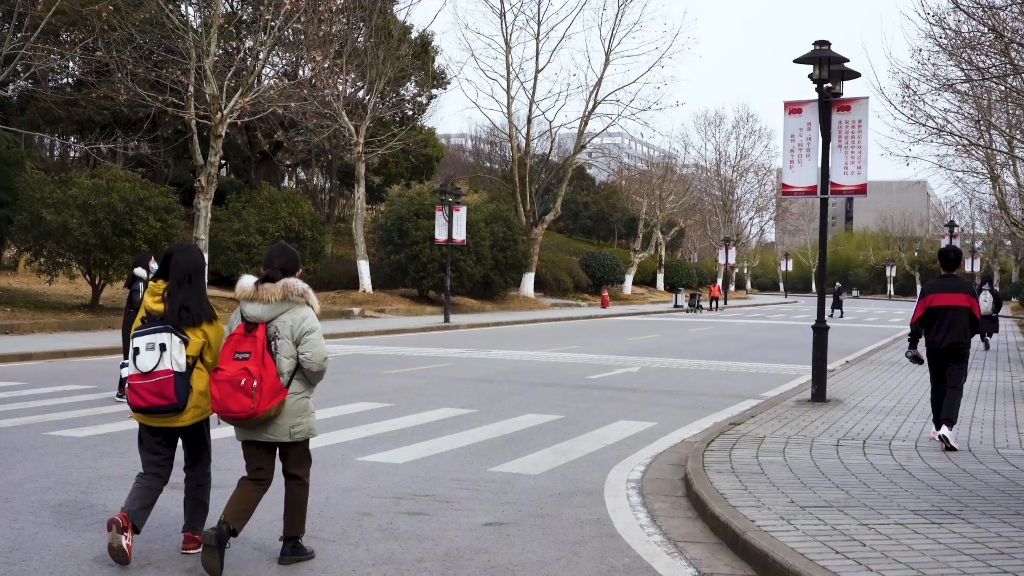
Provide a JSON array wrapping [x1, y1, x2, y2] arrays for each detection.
[[874, 0, 1024, 235]]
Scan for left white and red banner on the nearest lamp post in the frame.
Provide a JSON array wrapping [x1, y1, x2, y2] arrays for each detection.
[[781, 100, 818, 198]]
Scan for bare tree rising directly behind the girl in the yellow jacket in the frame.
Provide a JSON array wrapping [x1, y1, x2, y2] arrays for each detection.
[[95, 0, 318, 259]]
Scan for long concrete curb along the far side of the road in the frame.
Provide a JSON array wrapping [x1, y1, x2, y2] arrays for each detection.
[[0, 302, 790, 364]]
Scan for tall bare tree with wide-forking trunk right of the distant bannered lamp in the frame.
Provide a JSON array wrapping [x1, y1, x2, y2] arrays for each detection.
[[457, 0, 684, 297]]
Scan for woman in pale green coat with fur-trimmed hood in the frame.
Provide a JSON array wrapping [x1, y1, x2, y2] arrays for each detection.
[[203, 242, 327, 576]]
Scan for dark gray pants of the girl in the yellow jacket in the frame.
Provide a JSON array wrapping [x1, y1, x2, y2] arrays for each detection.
[[121, 418, 212, 534]]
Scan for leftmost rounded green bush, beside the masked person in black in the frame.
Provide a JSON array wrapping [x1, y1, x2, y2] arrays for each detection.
[[10, 167, 183, 306]]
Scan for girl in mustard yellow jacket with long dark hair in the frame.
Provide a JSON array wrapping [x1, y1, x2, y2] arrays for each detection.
[[106, 244, 224, 566]]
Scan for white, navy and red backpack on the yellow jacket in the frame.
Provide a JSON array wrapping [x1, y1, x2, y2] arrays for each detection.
[[125, 316, 199, 414]]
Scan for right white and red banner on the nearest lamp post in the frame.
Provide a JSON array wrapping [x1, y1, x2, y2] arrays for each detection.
[[828, 97, 868, 197]]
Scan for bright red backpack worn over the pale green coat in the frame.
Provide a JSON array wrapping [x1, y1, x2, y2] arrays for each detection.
[[210, 318, 299, 428]]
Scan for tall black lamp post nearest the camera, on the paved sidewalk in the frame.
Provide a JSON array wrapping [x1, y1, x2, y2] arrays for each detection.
[[793, 40, 860, 402]]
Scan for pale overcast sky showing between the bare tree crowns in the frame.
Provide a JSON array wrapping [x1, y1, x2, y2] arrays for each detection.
[[411, 0, 925, 186]]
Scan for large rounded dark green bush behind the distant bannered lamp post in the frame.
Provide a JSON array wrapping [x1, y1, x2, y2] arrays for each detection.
[[373, 184, 529, 298]]
